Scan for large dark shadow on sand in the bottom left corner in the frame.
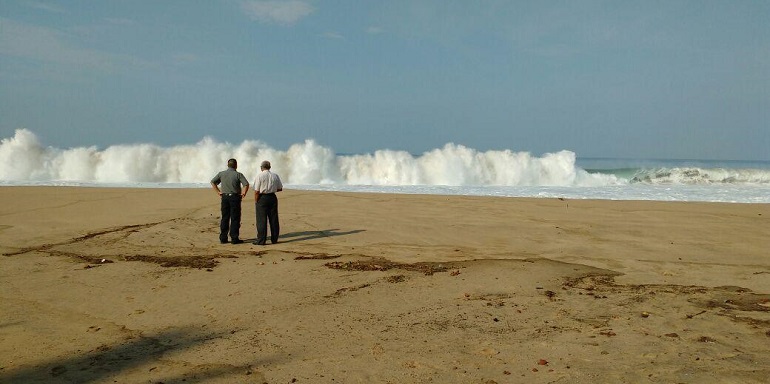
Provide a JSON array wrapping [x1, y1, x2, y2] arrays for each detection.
[[0, 327, 274, 384]]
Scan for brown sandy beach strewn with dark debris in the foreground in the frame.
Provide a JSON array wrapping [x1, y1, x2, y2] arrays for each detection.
[[0, 187, 770, 383]]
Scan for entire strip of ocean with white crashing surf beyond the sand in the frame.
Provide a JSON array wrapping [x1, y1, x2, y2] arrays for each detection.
[[0, 129, 770, 203]]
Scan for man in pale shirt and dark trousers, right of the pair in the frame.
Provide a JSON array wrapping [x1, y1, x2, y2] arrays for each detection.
[[254, 160, 283, 245]]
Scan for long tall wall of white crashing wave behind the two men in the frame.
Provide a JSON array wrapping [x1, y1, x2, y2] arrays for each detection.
[[0, 129, 616, 187]]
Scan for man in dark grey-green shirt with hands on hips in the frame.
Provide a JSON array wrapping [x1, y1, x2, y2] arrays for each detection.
[[211, 159, 249, 244]]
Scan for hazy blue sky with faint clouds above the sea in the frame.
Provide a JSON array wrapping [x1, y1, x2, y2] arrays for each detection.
[[0, 0, 770, 161]]
